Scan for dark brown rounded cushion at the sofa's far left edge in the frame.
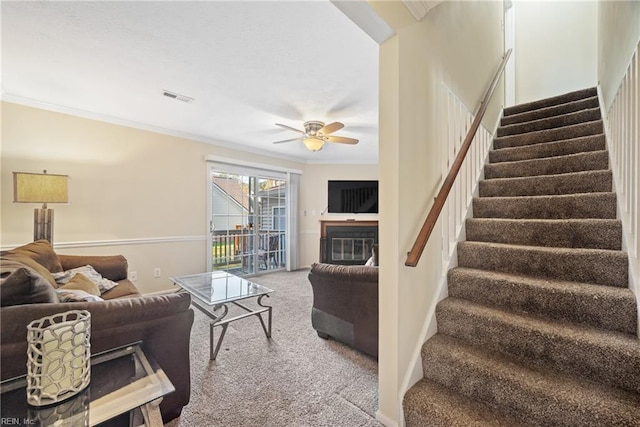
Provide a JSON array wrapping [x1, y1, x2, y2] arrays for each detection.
[[0, 260, 58, 307]]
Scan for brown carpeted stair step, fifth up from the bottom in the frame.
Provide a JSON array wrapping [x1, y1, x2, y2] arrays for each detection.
[[458, 242, 629, 288]]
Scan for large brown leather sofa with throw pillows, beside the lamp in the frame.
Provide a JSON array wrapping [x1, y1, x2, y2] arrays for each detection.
[[0, 240, 193, 422]]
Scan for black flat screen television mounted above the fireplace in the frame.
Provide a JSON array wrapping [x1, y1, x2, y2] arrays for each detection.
[[327, 181, 378, 213]]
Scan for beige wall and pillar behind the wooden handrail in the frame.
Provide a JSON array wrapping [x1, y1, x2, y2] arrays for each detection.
[[370, 1, 504, 425]]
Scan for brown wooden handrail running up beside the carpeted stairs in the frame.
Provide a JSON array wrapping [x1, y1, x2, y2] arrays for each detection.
[[404, 49, 511, 267]]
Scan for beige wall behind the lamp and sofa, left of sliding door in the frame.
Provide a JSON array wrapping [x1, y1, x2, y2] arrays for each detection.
[[0, 102, 311, 293]]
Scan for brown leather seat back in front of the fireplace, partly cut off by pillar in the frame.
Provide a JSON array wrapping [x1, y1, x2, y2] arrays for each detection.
[[308, 263, 378, 358]]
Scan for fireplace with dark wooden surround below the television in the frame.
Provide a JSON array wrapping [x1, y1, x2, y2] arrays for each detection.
[[320, 221, 378, 265]]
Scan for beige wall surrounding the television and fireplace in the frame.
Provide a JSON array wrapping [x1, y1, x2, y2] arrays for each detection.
[[299, 164, 378, 267]]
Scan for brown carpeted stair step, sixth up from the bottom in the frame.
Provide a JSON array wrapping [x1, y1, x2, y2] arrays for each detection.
[[465, 218, 622, 251]]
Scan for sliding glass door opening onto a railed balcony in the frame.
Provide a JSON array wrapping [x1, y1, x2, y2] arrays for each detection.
[[209, 166, 287, 275]]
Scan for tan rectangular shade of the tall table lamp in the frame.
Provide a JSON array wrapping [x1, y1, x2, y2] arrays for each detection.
[[13, 172, 69, 203]]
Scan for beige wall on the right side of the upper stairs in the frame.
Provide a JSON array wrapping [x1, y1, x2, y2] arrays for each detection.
[[597, 1, 640, 110]]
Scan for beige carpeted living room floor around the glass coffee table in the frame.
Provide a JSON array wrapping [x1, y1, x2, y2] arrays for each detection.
[[167, 270, 381, 427]]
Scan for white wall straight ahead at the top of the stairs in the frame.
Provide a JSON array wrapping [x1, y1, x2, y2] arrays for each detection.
[[514, 0, 598, 104]]
